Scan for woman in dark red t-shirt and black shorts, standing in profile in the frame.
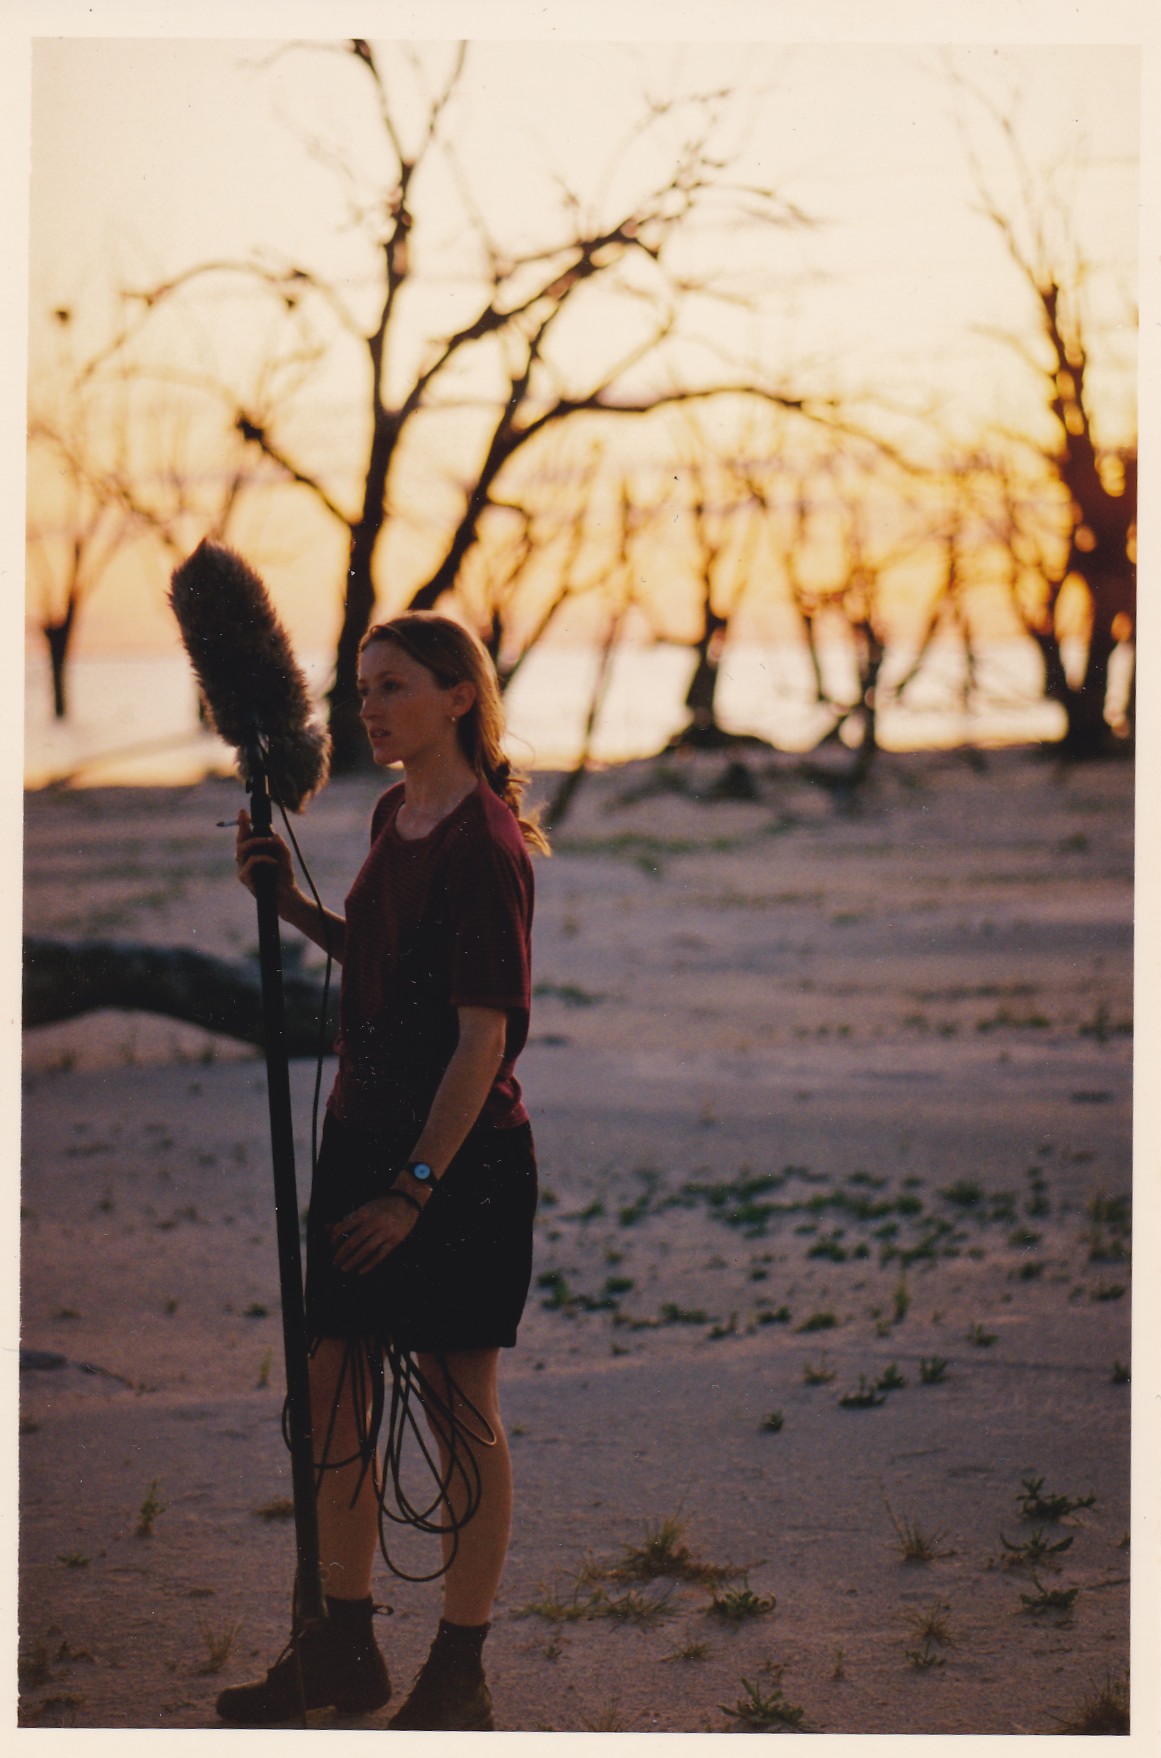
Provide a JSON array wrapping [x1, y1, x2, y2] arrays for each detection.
[[218, 614, 547, 1730]]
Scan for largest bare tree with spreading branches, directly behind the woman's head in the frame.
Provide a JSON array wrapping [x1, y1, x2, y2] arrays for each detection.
[[115, 39, 825, 770]]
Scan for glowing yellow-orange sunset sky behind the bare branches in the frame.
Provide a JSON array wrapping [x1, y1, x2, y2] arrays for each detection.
[[4, 4, 1143, 791]]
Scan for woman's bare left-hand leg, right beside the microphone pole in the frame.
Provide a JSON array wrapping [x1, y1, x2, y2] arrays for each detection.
[[310, 1338, 378, 1600]]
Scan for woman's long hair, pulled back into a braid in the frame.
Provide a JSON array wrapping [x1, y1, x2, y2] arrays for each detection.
[[359, 610, 551, 854]]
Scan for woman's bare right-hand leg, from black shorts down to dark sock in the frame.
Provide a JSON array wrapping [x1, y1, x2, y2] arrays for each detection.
[[417, 1348, 512, 1626]]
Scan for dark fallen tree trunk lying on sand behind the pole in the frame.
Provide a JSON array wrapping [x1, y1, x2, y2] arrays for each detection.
[[23, 935, 338, 1057]]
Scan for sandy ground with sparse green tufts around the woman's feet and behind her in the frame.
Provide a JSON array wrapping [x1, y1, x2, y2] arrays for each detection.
[[19, 738, 1133, 1733]]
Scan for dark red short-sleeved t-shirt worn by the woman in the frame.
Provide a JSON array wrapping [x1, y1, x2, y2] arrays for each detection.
[[327, 782, 533, 1134]]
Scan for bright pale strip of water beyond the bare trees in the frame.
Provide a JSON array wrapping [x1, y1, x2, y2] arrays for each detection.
[[25, 642, 1062, 788]]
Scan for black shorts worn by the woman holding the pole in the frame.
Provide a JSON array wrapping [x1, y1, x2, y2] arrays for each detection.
[[306, 1111, 537, 1354]]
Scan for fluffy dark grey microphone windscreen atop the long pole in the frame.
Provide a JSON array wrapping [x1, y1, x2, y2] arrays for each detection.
[[169, 540, 331, 812]]
